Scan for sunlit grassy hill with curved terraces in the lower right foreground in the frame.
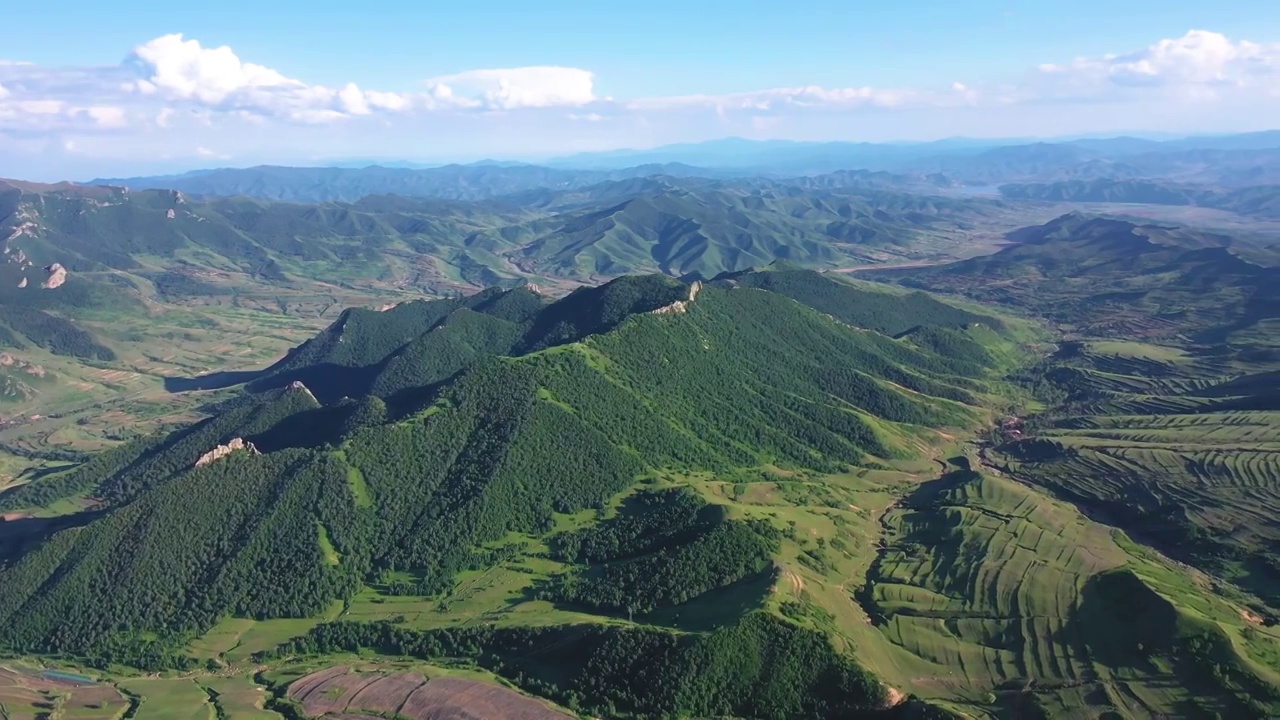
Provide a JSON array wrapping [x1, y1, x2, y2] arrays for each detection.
[[704, 448, 1280, 719]]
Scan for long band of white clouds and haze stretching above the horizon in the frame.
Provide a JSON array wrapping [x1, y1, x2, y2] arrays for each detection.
[[0, 29, 1280, 174]]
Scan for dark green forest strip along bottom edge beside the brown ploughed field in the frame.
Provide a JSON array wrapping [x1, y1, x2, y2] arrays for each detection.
[[262, 614, 901, 720]]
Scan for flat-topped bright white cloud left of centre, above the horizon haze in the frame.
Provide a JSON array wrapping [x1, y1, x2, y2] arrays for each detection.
[[426, 65, 596, 110]]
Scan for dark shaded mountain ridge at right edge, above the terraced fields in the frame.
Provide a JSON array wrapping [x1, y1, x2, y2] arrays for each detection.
[[877, 213, 1280, 345]]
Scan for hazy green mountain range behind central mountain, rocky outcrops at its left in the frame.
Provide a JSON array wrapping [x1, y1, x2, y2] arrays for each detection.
[[0, 174, 1002, 360]]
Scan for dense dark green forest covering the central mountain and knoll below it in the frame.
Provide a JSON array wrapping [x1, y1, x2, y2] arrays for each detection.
[[0, 271, 998, 662]]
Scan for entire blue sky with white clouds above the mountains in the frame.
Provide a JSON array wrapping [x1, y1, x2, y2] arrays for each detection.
[[0, 0, 1280, 181]]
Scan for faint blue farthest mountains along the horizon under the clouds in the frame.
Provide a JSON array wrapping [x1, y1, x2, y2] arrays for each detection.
[[90, 132, 1280, 202]]
